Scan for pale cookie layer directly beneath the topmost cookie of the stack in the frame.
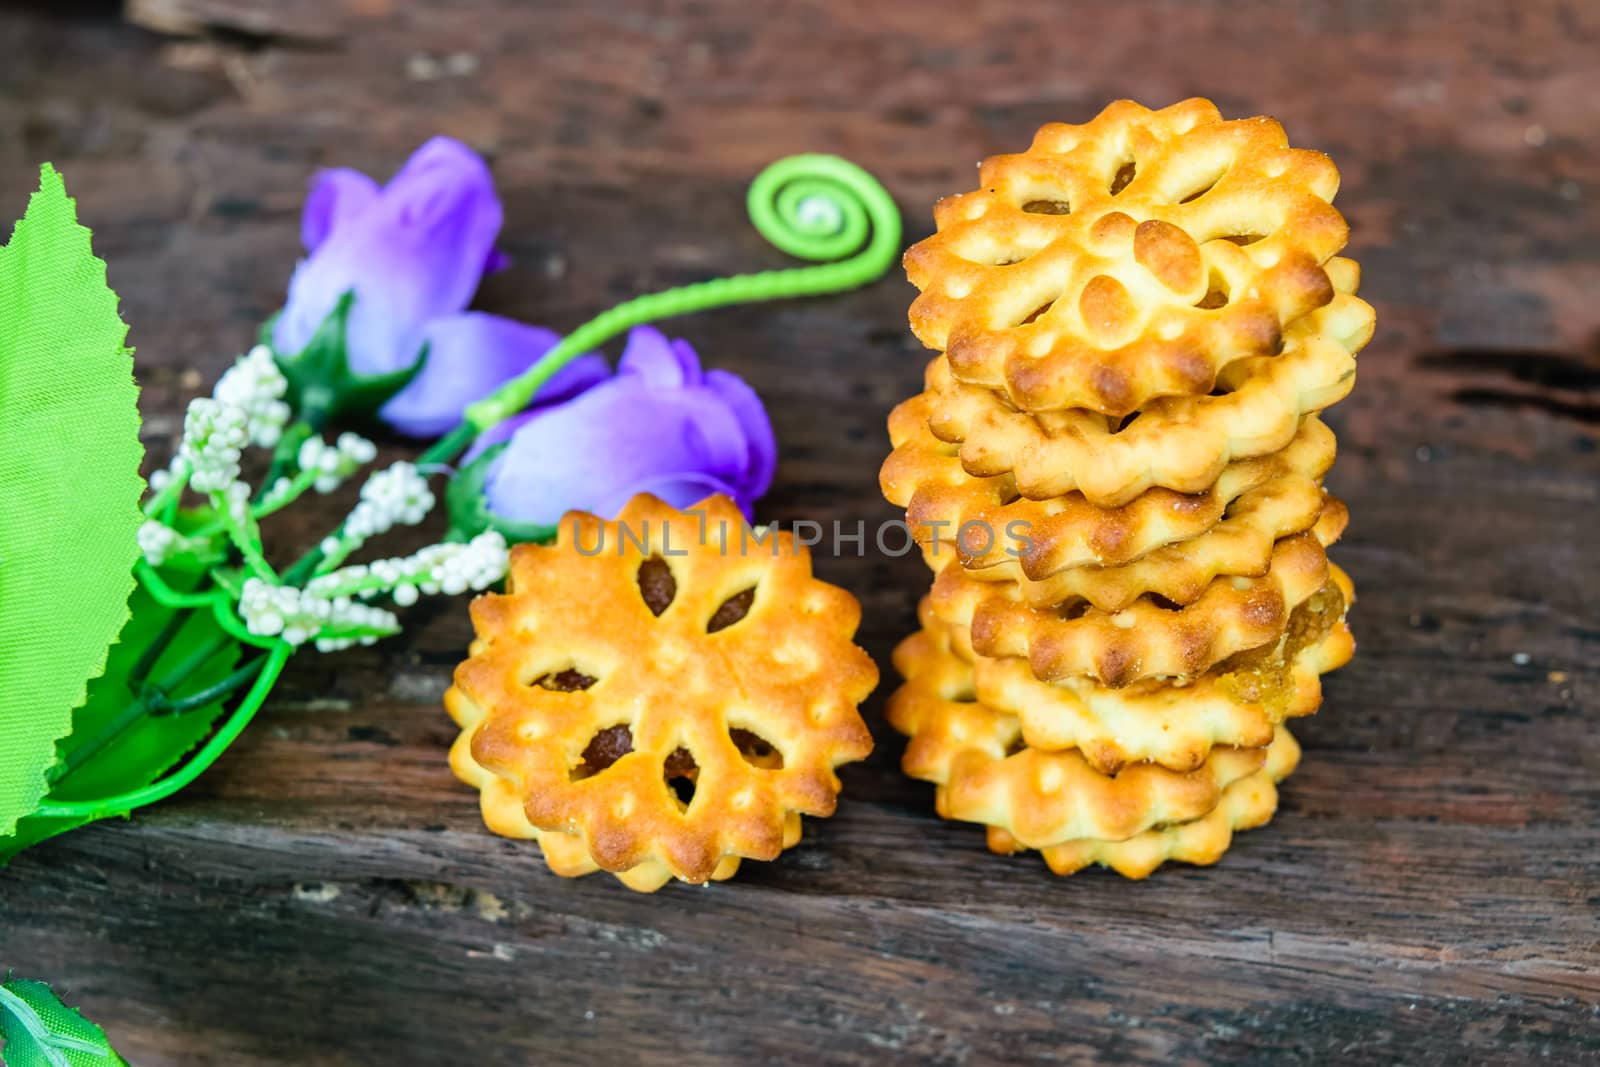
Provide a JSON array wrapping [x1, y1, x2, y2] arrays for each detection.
[[928, 258, 1373, 507]]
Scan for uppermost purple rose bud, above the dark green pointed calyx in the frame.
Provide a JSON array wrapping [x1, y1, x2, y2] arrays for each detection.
[[272, 138, 502, 383]]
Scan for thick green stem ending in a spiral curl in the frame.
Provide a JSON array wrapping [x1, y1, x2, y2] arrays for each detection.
[[418, 154, 901, 466]]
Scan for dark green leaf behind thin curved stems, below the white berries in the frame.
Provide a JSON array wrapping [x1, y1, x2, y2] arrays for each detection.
[[0, 588, 242, 864]]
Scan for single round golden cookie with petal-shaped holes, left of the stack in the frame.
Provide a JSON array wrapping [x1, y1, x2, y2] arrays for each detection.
[[445, 494, 877, 888]]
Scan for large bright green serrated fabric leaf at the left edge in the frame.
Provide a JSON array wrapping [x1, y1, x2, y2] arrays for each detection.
[[0, 165, 144, 835]]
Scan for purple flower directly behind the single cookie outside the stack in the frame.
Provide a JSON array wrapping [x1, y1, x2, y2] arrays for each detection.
[[464, 326, 778, 526]]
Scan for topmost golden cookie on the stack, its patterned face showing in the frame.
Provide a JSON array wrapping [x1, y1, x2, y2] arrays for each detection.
[[906, 99, 1349, 416]]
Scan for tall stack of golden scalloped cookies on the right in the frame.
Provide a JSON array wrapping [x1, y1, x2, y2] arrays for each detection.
[[882, 99, 1373, 877]]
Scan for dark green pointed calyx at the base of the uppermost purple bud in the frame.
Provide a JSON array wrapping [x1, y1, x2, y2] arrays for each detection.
[[270, 290, 427, 430]]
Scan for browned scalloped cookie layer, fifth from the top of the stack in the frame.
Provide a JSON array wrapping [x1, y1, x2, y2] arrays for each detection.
[[931, 533, 1328, 686]]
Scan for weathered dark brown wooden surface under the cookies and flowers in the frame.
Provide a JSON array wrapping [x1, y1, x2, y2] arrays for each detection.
[[0, 0, 1600, 1065]]
